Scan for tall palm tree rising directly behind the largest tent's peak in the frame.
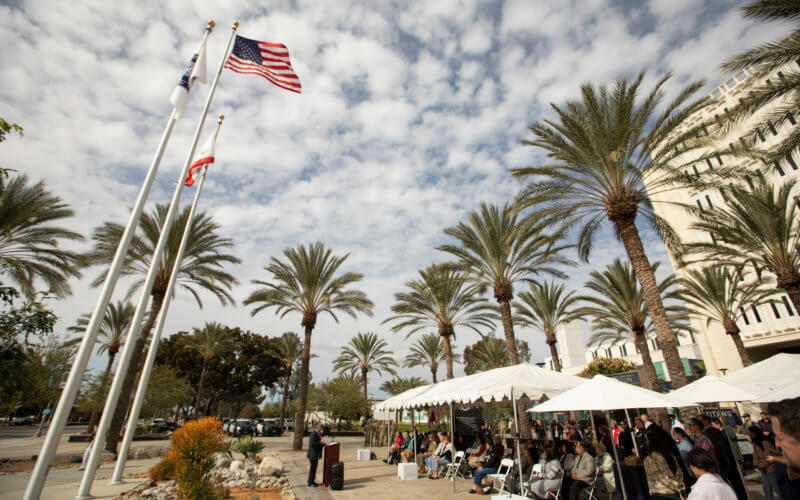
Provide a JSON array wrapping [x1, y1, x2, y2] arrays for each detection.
[[438, 203, 571, 364]]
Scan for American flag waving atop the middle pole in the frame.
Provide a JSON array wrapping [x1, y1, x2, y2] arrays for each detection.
[[225, 35, 301, 94]]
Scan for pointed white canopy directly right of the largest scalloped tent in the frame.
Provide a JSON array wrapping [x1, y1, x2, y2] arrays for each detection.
[[529, 375, 692, 413]]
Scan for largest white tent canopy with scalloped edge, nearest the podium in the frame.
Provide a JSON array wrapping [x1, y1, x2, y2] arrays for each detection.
[[381, 364, 586, 409]]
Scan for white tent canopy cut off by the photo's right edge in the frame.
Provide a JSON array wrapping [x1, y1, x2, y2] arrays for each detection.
[[722, 353, 800, 397]]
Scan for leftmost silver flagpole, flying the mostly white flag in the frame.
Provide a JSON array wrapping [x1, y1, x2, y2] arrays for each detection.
[[23, 21, 214, 500]]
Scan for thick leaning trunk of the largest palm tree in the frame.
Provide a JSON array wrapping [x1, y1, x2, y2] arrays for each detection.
[[614, 217, 688, 389]]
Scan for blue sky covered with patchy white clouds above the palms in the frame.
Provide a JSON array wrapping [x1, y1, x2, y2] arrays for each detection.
[[0, 0, 785, 398]]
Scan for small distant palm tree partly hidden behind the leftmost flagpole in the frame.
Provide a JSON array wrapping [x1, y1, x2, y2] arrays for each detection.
[[67, 300, 136, 432]]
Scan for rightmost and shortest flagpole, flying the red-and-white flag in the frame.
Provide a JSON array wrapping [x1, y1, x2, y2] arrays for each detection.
[[108, 115, 225, 484]]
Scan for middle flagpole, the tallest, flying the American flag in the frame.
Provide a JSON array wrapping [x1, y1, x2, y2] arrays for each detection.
[[75, 22, 239, 500]]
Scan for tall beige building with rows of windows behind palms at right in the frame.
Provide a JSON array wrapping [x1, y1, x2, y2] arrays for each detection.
[[652, 63, 800, 374]]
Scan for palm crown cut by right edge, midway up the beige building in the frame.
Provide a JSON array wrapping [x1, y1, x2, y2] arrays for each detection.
[[686, 176, 800, 311]]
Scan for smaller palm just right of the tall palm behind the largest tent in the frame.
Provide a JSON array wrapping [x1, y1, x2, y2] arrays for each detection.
[[514, 281, 581, 372]]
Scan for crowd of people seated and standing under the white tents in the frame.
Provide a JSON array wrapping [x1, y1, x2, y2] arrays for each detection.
[[376, 398, 800, 500]]
